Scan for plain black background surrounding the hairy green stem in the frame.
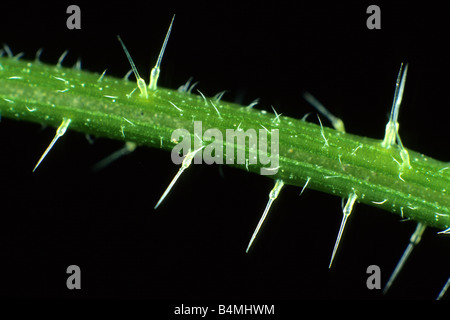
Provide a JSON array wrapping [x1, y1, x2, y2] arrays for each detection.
[[0, 1, 450, 305]]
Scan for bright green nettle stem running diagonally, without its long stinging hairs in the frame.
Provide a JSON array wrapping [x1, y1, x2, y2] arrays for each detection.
[[0, 58, 450, 230]]
